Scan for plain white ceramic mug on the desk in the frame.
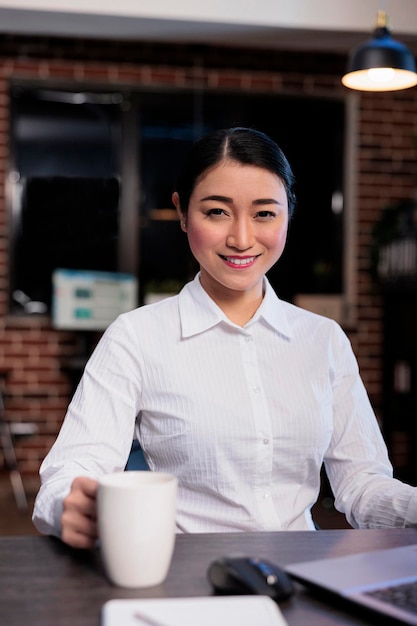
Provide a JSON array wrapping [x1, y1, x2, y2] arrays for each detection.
[[97, 471, 177, 587]]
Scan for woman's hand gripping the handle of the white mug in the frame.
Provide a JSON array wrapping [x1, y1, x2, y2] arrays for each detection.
[[61, 476, 98, 548]]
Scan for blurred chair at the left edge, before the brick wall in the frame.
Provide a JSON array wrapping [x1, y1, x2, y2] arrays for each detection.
[[0, 390, 38, 511]]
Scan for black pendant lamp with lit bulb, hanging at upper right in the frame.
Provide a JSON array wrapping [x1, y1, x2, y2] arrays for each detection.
[[342, 11, 417, 91]]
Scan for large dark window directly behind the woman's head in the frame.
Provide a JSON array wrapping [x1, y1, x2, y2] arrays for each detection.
[[138, 93, 345, 300]]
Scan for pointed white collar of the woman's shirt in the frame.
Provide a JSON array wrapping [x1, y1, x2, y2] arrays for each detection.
[[179, 272, 292, 338]]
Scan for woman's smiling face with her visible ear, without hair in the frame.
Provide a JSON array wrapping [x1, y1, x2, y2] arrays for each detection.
[[173, 160, 288, 298]]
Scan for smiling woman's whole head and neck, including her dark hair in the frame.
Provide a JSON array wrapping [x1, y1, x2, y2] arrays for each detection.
[[173, 127, 294, 326]]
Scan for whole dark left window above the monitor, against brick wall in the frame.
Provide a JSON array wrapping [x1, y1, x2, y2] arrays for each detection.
[[11, 89, 120, 310]]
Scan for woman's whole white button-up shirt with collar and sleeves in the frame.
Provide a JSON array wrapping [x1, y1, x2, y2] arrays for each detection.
[[33, 275, 417, 535]]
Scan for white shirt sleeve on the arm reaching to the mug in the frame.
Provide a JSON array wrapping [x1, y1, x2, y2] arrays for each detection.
[[32, 316, 141, 536]]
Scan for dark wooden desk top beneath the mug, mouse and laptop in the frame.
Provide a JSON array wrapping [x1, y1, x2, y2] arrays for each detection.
[[0, 529, 417, 626]]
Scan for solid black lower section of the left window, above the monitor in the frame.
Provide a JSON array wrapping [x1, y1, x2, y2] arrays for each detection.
[[15, 176, 119, 306]]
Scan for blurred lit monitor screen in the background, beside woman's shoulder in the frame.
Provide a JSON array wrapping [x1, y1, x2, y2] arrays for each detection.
[[52, 269, 138, 330]]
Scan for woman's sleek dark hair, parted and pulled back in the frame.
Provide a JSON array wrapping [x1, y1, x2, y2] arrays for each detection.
[[176, 126, 295, 218]]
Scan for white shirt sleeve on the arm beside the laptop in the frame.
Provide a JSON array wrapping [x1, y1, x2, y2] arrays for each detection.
[[325, 322, 417, 528]]
